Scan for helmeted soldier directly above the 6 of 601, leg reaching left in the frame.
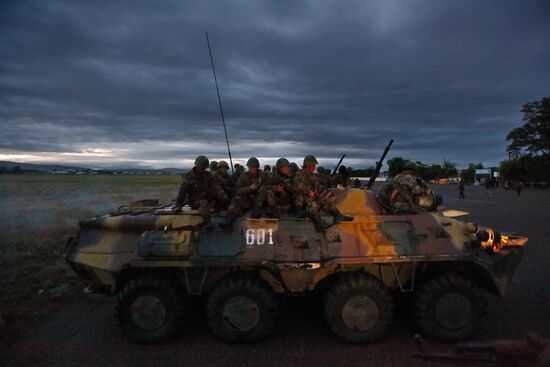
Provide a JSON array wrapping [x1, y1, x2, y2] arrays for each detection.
[[220, 157, 262, 230]]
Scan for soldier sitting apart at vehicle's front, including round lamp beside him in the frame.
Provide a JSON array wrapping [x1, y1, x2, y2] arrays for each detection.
[[378, 162, 441, 214]]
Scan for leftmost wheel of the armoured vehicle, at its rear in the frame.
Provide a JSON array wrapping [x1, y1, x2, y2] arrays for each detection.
[[116, 275, 188, 344]]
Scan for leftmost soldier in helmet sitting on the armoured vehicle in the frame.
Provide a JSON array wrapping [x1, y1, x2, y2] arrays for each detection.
[[174, 155, 228, 229]]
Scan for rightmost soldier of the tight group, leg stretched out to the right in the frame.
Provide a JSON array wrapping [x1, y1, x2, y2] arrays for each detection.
[[292, 155, 353, 231]]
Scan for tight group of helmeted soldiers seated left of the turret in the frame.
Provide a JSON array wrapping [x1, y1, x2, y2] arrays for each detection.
[[174, 155, 353, 231]]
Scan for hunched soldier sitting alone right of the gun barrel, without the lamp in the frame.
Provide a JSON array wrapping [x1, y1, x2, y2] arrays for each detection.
[[378, 161, 436, 214]]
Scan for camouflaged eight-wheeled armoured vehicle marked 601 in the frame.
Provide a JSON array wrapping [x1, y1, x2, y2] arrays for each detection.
[[66, 189, 527, 343]]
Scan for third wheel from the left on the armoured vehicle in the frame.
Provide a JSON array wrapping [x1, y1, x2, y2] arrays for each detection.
[[325, 273, 393, 342]]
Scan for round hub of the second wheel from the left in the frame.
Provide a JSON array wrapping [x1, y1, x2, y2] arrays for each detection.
[[222, 296, 260, 332]]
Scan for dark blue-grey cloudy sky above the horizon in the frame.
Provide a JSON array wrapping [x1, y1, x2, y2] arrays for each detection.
[[0, 0, 550, 168]]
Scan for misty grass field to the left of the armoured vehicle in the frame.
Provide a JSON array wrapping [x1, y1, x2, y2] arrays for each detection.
[[0, 175, 181, 322]]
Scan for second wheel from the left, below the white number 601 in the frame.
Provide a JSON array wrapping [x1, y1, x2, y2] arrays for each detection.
[[206, 275, 277, 342]]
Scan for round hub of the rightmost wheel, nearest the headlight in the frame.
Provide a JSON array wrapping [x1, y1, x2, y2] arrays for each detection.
[[435, 293, 472, 330]]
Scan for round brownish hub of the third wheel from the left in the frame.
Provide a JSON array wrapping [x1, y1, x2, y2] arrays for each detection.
[[342, 295, 380, 332]]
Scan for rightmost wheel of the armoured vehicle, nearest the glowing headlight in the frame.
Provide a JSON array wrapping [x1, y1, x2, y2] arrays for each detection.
[[413, 273, 487, 341]]
